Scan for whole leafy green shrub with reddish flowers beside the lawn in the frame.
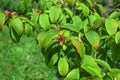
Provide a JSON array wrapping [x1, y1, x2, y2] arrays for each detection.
[[0, 0, 120, 80]]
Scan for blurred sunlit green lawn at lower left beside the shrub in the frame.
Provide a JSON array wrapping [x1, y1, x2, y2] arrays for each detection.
[[0, 27, 58, 80]]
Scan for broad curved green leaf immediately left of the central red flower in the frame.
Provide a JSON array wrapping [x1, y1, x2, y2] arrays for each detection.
[[37, 30, 58, 48]]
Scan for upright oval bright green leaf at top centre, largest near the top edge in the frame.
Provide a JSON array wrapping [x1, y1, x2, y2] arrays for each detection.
[[49, 6, 62, 23]]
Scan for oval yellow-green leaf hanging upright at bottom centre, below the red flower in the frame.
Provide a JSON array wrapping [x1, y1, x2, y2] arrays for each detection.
[[58, 57, 69, 76]]
